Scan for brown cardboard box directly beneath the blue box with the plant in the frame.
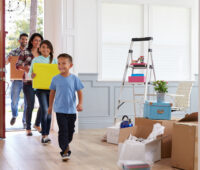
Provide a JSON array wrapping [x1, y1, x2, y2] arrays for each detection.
[[135, 118, 176, 158]]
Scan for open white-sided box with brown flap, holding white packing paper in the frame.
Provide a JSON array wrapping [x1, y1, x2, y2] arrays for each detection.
[[118, 126, 162, 164]]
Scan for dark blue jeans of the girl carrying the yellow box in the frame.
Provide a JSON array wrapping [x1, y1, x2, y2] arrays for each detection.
[[36, 90, 51, 136]]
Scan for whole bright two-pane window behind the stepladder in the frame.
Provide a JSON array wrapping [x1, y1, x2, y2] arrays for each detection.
[[100, 2, 197, 81]]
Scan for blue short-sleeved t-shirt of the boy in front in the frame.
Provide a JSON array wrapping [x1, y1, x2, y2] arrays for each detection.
[[50, 74, 84, 114]]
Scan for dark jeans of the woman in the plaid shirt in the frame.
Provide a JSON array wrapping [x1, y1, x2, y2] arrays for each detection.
[[23, 84, 41, 130]]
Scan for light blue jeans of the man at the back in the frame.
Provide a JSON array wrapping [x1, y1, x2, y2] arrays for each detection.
[[11, 80, 27, 123]]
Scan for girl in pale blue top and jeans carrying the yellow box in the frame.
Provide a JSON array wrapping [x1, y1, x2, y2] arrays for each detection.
[[28, 40, 57, 144]]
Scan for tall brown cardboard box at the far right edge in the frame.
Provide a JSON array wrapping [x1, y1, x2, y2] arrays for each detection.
[[171, 122, 198, 170]]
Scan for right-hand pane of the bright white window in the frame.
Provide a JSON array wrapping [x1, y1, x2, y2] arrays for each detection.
[[149, 6, 191, 80]]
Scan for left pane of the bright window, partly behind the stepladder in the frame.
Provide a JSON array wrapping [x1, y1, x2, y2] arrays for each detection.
[[102, 3, 143, 80]]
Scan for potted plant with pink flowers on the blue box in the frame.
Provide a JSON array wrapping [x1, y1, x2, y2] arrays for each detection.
[[153, 80, 168, 103]]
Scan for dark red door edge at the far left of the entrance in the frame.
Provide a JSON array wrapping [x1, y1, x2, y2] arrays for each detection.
[[0, 0, 6, 138]]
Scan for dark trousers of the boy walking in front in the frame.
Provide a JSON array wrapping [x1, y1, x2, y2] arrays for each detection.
[[56, 113, 76, 152]]
